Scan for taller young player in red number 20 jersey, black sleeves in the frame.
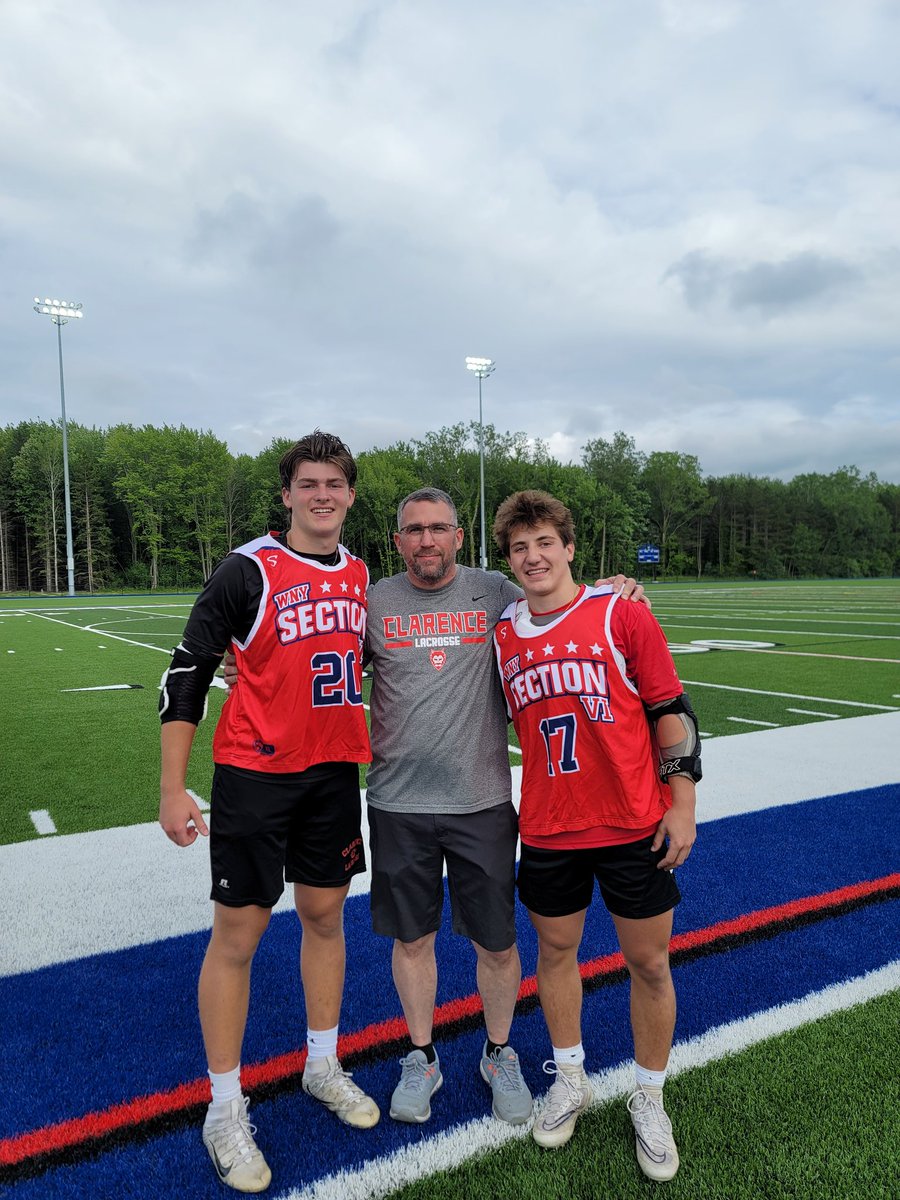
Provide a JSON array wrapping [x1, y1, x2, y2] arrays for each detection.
[[160, 430, 379, 1192]]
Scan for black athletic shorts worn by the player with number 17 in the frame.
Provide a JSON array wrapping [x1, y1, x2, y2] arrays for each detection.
[[518, 834, 682, 919]]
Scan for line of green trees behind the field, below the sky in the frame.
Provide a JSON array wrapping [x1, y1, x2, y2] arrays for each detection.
[[0, 421, 900, 592]]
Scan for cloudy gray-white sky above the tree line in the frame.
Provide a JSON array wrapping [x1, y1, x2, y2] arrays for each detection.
[[0, 0, 900, 481]]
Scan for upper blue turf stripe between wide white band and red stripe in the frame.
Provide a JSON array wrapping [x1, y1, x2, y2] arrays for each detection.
[[0, 788, 900, 1136]]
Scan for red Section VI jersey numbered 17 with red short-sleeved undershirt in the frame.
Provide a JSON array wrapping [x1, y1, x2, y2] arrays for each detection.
[[494, 588, 682, 845]]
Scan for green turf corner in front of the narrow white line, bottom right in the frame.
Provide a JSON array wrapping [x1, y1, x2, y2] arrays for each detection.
[[381, 992, 900, 1200]]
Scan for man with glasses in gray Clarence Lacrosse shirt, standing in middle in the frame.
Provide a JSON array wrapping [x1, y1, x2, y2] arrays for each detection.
[[366, 487, 643, 1124]]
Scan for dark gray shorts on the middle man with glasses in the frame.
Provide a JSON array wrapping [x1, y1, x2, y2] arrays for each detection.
[[368, 802, 518, 952]]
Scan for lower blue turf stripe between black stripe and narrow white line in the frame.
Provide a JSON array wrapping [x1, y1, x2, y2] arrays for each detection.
[[0, 900, 900, 1200]]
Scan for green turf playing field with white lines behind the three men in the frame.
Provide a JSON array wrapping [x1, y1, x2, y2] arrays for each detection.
[[0, 581, 900, 842]]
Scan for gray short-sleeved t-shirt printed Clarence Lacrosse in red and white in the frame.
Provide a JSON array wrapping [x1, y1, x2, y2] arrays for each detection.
[[366, 565, 522, 814]]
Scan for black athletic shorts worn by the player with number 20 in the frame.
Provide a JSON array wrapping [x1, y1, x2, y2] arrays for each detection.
[[209, 762, 366, 908]]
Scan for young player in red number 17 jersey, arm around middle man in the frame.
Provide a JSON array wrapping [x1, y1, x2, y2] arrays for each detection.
[[493, 491, 701, 1180]]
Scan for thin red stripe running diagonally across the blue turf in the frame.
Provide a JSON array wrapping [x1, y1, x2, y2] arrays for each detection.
[[0, 872, 900, 1166]]
